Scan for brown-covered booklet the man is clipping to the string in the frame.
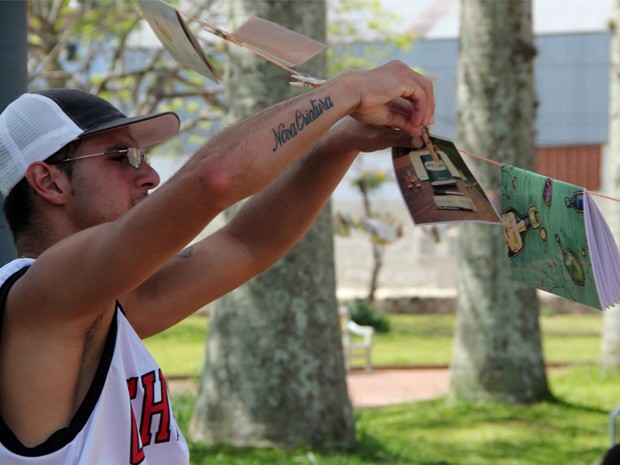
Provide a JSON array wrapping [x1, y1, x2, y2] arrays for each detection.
[[392, 136, 501, 225]]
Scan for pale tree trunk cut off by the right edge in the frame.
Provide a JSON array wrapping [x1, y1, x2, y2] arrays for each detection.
[[601, 0, 620, 368]]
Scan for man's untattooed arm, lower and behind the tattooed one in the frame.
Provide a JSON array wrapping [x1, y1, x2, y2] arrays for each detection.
[[123, 118, 418, 337]]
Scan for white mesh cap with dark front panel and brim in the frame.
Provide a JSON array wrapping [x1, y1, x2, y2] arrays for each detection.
[[0, 89, 179, 196]]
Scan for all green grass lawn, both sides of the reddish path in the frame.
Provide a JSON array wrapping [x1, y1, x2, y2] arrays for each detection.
[[146, 311, 620, 465]]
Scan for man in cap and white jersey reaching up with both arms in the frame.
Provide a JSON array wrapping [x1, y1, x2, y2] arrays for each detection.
[[0, 62, 434, 465]]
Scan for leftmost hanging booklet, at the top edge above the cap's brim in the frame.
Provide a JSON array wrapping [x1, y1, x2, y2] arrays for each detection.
[[138, 0, 222, 82]]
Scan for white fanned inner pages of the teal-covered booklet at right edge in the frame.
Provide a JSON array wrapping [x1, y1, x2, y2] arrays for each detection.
[[583, 189, 620, 309]]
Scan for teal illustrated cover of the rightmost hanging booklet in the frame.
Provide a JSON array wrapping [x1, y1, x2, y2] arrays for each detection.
[[501, 165, 601, 308]]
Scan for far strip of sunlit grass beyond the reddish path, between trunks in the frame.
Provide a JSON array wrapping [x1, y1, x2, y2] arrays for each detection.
[[145, 311, 603, 376]]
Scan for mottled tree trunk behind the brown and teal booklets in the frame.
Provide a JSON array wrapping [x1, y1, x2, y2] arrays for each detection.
[[450, 0, 549, 402]]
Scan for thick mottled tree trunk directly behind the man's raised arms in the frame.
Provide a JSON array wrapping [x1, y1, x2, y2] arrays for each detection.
[[190, 0, 354, 447]]
